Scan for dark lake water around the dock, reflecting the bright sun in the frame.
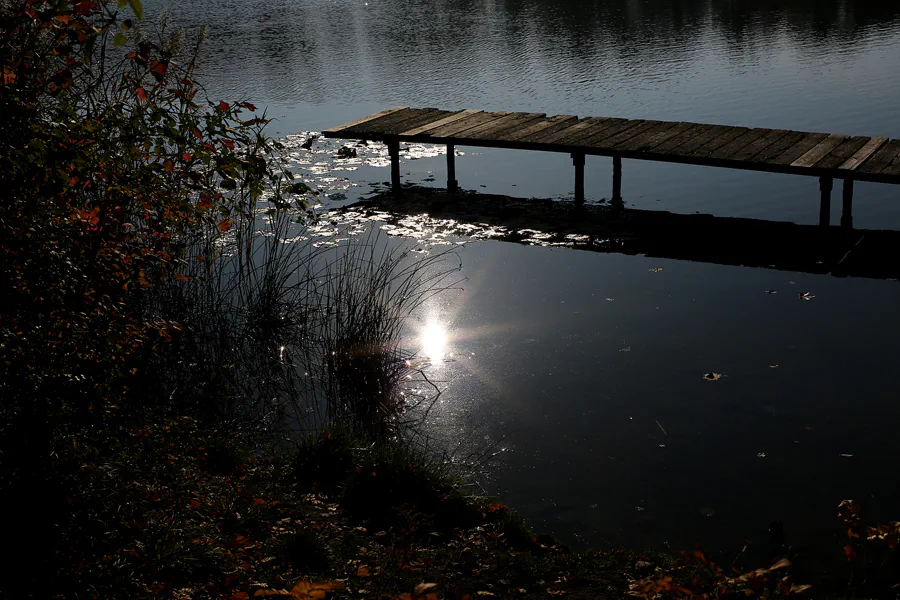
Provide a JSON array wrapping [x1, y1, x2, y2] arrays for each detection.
[[147, 0, 900, 549]]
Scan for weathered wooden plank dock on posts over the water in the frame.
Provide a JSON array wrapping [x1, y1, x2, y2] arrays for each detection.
[[323, 106, 900, 228]]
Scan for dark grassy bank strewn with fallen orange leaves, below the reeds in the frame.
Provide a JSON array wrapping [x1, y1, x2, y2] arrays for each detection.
[[17, 410, 892, 600]]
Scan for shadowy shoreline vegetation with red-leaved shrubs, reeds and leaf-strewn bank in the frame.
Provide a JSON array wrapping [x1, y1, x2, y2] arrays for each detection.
[[0, 0, 898, 600]]
